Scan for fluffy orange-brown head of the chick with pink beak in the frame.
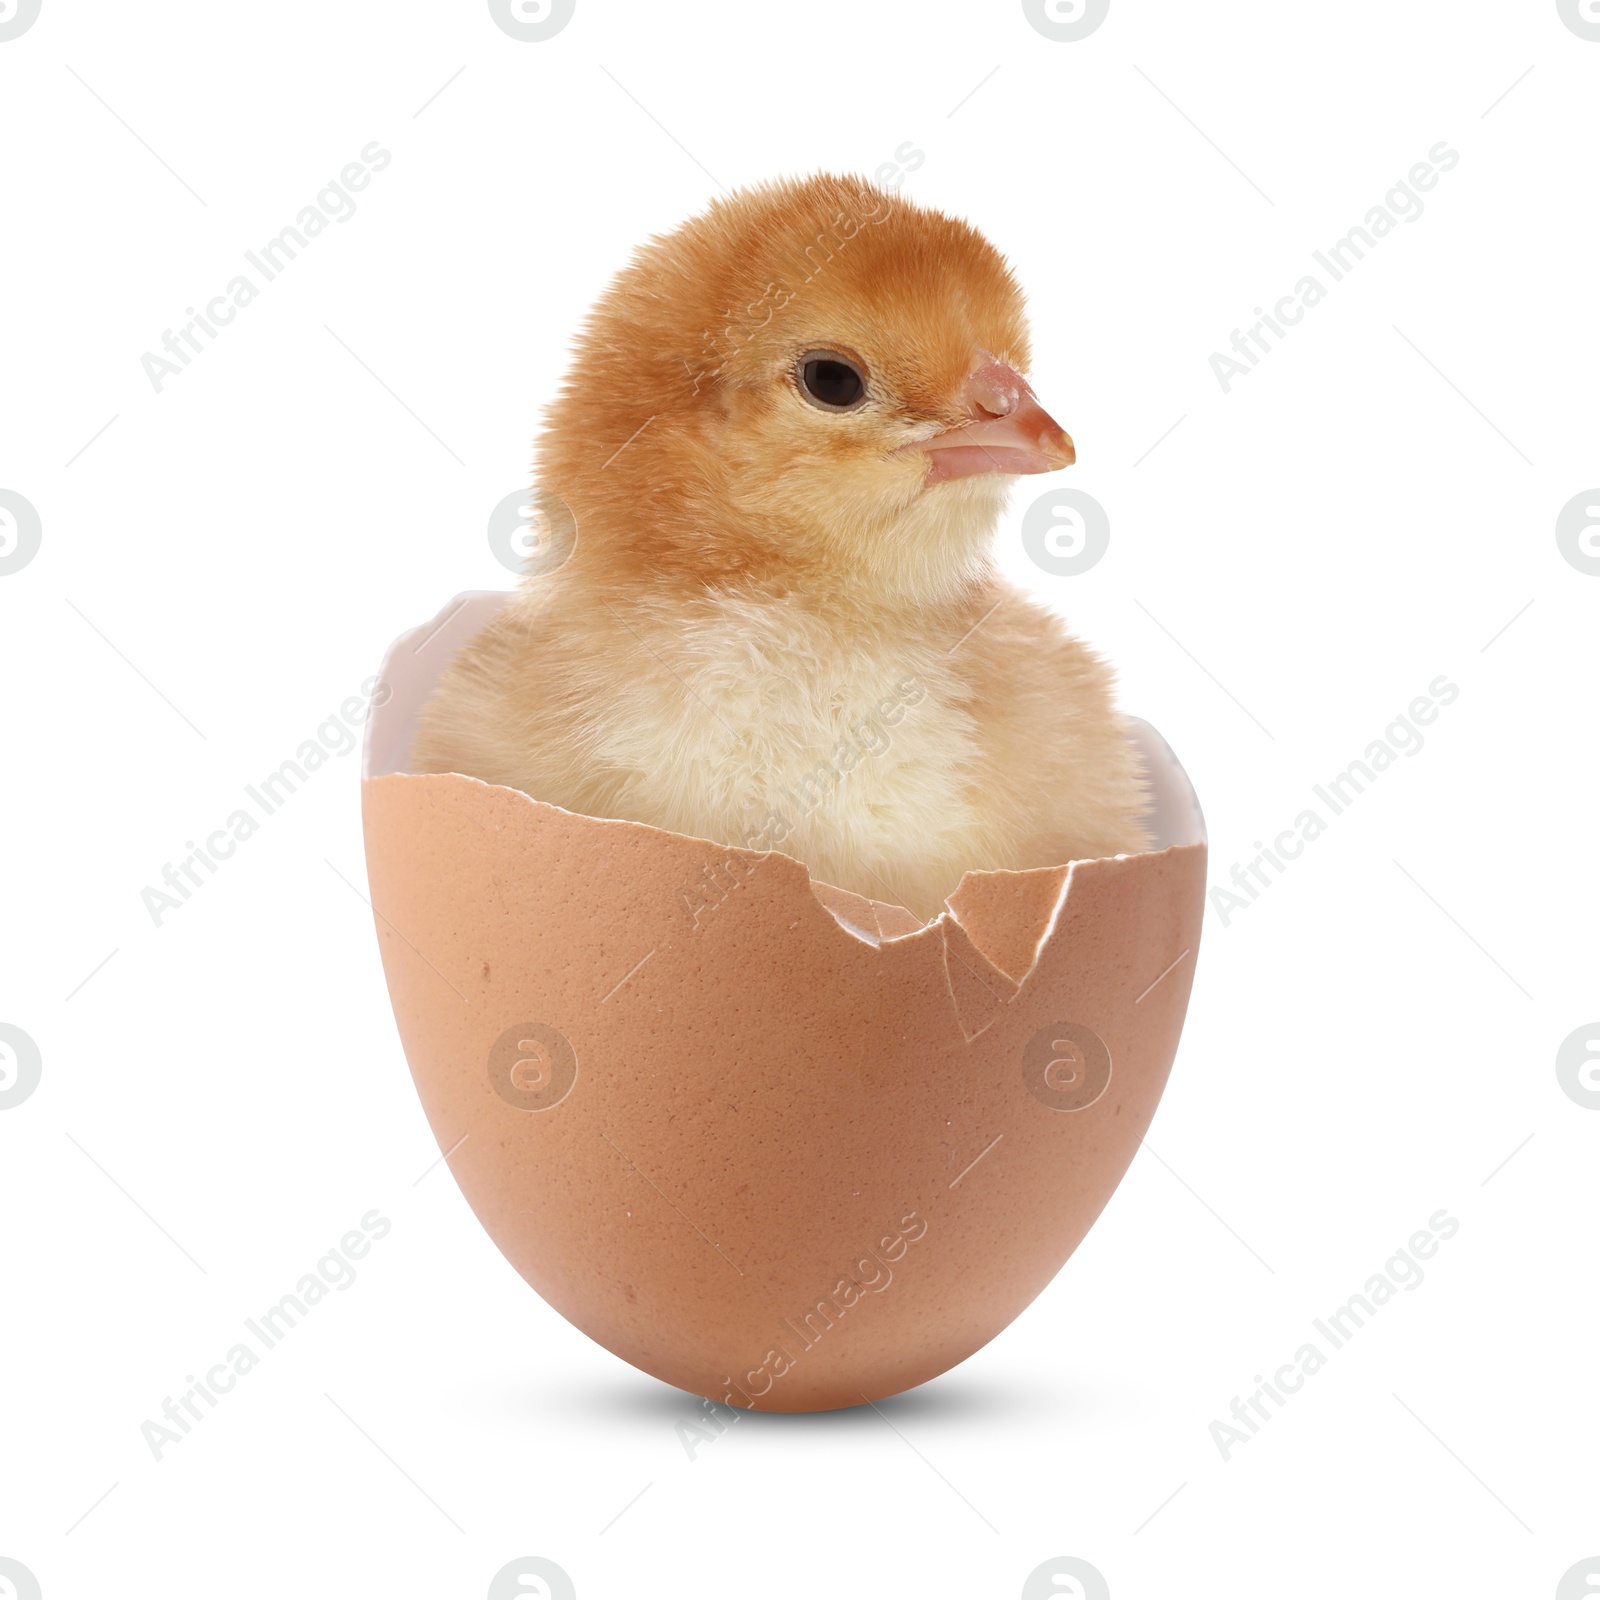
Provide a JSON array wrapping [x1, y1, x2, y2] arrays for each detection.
[[541, 176, 1074, 600]]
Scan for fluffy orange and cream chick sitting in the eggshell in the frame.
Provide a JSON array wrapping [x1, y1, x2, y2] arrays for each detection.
[[414, 176, 1147, 918]]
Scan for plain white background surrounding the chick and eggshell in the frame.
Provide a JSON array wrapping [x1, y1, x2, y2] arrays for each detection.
[[0, 0, 1600, 1600]]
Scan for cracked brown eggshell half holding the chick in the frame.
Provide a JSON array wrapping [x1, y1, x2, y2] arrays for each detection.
[[363, 594, 1206, 1411]]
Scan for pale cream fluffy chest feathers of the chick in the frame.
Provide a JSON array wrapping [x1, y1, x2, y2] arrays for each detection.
[[595, 602, 978, 880]]
